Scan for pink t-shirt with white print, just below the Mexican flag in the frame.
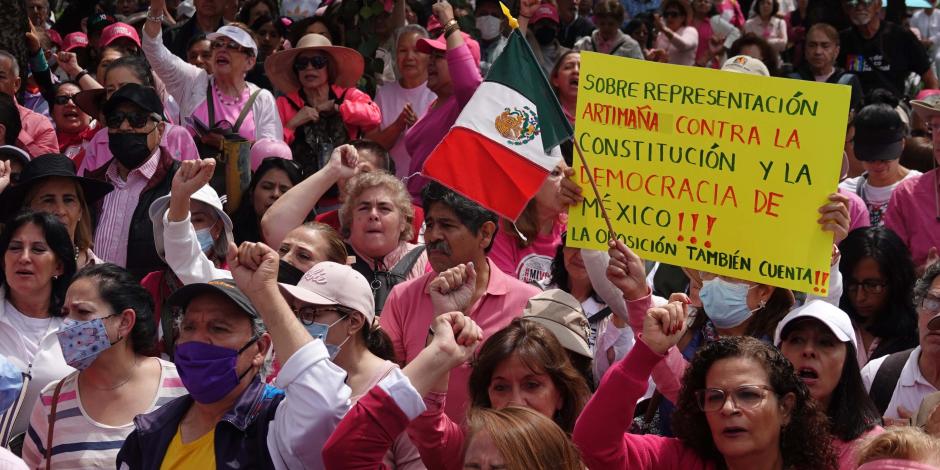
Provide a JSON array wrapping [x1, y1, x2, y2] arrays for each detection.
[[489, 215, 567, 283]]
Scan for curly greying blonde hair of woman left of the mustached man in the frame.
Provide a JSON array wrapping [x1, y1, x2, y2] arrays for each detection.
[[339, 171, 415, 241]]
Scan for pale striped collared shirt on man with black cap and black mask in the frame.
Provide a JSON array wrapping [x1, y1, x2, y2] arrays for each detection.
[[95, 151, 160, 267]]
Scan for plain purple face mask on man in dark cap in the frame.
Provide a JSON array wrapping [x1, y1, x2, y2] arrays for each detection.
[[175, 336, 258, 404]]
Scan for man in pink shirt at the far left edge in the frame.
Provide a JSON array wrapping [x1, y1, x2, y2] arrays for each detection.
[[0, 50, 59, 157]]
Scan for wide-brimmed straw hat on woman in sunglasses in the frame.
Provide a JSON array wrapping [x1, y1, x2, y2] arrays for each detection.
[[264, 34, 365, 93]]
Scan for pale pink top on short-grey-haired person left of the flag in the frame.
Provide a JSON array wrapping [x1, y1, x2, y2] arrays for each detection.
[[375, 81, 437, 178]]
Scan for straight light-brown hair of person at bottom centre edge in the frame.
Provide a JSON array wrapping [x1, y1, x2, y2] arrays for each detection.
[[467, 406, 585, 470]]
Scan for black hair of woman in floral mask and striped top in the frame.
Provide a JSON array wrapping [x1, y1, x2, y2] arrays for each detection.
[[72, 263, 157, 354]]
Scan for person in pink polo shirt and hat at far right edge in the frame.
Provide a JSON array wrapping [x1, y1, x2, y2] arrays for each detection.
[[885, 95, 940, 272]]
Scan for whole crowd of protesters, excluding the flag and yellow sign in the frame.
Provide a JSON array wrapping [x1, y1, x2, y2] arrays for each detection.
[[0, 0, 940, 470]]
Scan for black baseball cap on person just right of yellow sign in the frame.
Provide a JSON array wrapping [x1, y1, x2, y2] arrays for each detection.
[[853, 103, 907, 162]]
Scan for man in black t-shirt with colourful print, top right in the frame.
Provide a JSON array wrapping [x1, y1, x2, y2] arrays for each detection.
[[836, 0, 937, 99]]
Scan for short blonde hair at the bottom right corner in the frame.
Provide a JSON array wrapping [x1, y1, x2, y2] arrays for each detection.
[[856, 426, 940, 465]]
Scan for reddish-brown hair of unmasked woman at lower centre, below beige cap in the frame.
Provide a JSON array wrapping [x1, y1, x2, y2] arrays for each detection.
[[468, 318, 591, 432]]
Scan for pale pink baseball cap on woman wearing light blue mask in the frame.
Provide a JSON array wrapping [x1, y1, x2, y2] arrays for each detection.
[[280, 261, 375, 325]]
